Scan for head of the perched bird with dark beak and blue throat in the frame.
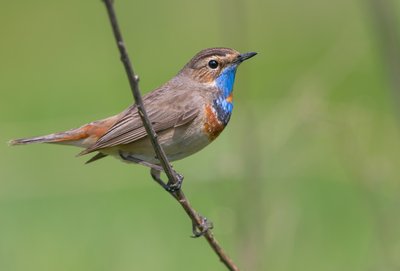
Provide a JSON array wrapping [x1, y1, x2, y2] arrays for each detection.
[[181, 48, 257, 94]]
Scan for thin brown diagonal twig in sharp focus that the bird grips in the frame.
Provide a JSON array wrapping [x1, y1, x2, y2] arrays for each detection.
[[103, 0, 239, 271]]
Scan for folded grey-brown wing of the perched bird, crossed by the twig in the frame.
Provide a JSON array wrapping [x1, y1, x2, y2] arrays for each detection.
[[80, 86, 199, 154]]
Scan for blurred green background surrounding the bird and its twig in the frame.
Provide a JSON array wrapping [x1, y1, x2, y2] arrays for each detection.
[[0, 0, 400, 271]]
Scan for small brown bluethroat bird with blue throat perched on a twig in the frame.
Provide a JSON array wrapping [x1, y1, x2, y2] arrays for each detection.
[[10, 48, 256, 189]]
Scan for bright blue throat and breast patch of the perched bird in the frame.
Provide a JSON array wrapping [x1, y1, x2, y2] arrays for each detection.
[[213, 65, 237, 126]]
